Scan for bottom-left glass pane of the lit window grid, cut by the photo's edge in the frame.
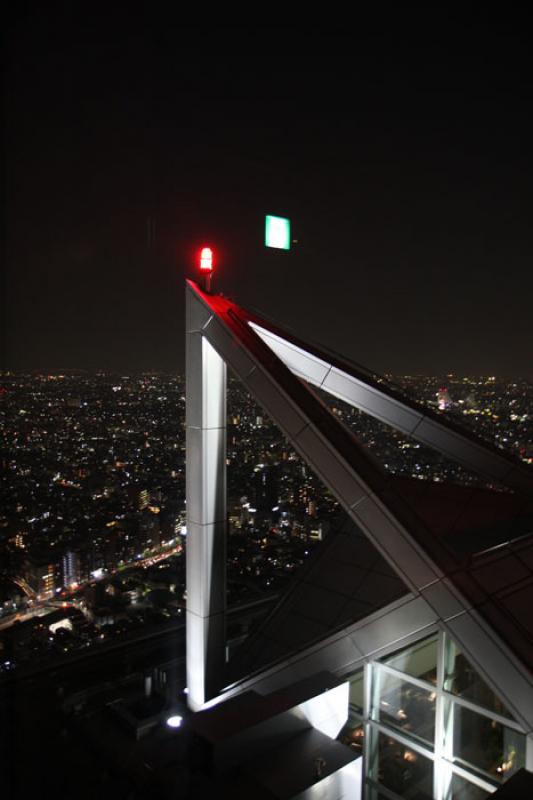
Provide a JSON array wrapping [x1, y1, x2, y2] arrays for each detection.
[[372, 733, 433, 800]]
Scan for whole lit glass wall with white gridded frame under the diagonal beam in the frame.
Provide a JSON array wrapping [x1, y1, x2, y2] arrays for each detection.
[[339, 632, 526, 800]]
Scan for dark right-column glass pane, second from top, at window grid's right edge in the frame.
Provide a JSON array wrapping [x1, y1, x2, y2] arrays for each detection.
[[453, 703, 525, 781]]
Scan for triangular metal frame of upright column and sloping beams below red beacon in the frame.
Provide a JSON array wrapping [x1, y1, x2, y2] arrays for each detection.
[[187, 282, 533, 731]]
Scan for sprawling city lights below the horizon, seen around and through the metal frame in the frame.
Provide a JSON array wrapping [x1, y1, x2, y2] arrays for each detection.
[[1, 368, 533, 676]]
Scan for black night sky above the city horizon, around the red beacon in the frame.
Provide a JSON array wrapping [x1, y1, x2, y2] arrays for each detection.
[[3, 10, 533, 378]]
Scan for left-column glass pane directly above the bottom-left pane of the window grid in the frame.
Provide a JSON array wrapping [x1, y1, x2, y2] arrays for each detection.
[[372, 669, 436, 748]]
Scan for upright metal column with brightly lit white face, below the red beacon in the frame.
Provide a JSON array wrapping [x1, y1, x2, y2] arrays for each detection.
[[186, 291, 226, 709]]
